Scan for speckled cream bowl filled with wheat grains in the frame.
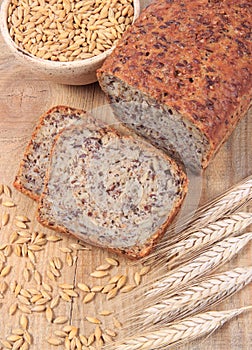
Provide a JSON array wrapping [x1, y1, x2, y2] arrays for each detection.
[[0, 0, 140, 85]]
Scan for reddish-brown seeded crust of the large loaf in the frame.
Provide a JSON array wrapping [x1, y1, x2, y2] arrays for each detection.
[[98, 0, 252, 168]]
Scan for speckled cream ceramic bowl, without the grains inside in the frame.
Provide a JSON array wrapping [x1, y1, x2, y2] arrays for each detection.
[[0, 0, 140, 85]]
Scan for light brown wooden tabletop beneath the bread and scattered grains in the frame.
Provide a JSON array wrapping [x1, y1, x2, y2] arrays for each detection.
[[0, 2, 252, 350]]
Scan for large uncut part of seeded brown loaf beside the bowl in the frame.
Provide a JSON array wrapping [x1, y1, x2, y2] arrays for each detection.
[[98, 0, 252, 171]]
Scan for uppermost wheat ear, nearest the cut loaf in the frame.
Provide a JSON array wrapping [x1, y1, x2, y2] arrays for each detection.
[[142, 175, 252, 264]]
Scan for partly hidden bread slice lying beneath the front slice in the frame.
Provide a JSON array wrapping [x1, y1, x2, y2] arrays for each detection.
[[14, 106, 89, 201]]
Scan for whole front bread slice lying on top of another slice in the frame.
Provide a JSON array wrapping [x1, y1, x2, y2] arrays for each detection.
[[38, 123, 188, 259]]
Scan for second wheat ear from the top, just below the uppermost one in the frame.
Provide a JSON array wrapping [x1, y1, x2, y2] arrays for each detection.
[[147, 212, 252, 269]]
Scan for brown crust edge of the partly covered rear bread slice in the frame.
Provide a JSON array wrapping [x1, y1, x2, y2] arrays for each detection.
[[13, 105, 89, 201]]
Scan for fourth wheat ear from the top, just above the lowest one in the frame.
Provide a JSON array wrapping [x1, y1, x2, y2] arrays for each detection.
[[134, 266, 252, 332]]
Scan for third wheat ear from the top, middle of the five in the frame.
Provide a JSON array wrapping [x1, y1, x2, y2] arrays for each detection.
[[143, 232, 252, 301]]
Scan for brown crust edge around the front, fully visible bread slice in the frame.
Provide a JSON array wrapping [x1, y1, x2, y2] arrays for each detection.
[[37, 121, 188, 260]]
